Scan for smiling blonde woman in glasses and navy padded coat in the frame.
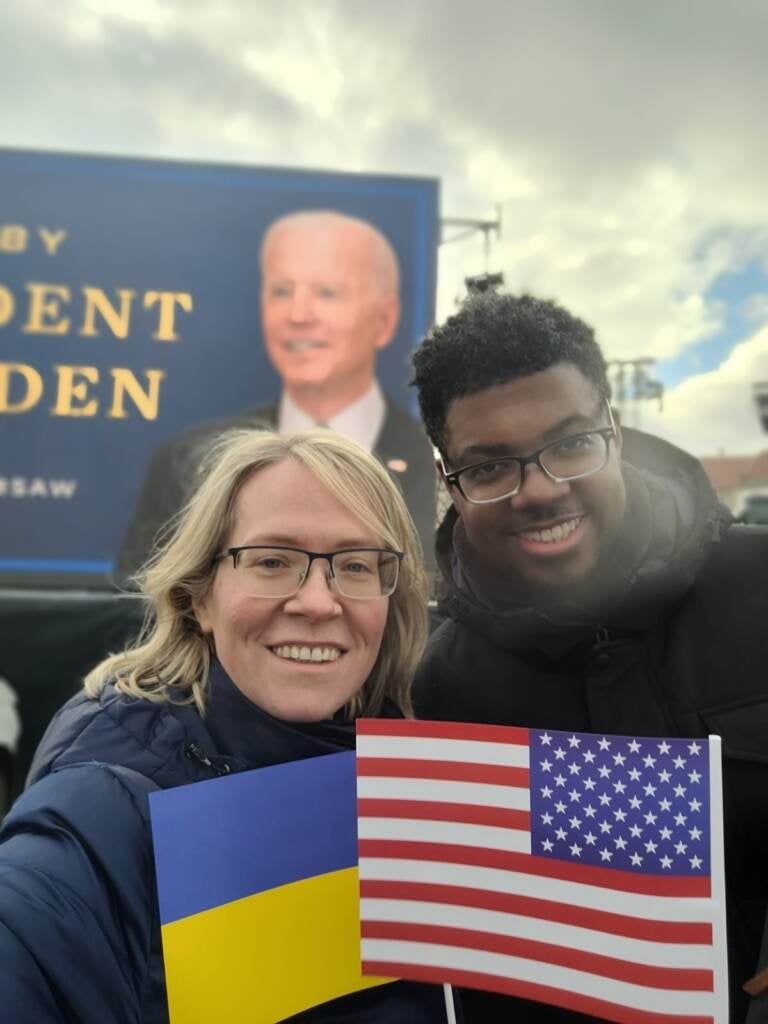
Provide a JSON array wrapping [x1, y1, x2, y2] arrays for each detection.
[[0, 431, 444, 1024]]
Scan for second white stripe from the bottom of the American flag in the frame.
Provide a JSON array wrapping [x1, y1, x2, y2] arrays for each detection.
[[360, 897, 715, 970]]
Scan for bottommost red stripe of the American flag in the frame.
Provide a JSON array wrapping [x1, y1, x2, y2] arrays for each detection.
[[362, 961, 714, 1024]]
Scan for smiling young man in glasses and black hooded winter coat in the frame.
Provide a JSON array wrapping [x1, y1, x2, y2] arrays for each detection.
[[414, 295, 768, 1024]]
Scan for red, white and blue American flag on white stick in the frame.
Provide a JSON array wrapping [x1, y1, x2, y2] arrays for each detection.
[[357, 719, 728, 1024]]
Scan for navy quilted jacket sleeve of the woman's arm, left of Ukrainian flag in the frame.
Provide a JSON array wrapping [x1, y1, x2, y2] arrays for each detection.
[[0, 762, 157, 1024]]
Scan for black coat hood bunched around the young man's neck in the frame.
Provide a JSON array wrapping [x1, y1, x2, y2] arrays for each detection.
[[436, 429, 732, 656]]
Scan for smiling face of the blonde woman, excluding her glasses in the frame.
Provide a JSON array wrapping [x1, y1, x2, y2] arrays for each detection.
[[196, 459, 389, 722]]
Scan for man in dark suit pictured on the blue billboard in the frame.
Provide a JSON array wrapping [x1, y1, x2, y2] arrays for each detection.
[[118, 210, 435, 580]]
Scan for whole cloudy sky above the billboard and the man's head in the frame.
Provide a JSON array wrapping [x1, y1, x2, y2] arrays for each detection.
[[0, 0, 768, 454]]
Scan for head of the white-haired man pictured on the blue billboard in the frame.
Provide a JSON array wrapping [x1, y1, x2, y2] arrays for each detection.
[[261, 222, 398, 400]]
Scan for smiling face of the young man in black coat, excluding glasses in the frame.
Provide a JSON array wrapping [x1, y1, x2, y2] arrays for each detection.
[[445, 362, 626, 593]]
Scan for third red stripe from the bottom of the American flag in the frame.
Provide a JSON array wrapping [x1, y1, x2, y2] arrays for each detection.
[[360, 879, 713, 946]]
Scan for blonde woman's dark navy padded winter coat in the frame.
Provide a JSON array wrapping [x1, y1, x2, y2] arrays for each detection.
[[0, 666, 454, 1024]]
